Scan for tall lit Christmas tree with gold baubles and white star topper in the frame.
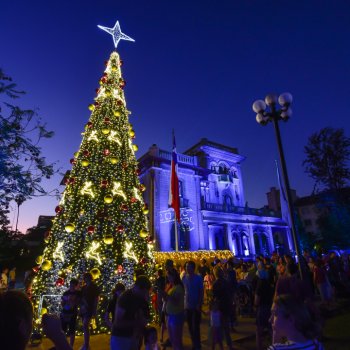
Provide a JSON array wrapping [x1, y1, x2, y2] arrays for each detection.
[[32, 22, 154, 333]]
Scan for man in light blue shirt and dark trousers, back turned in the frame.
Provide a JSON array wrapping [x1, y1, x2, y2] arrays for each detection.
[[182, 261, 203, 350]]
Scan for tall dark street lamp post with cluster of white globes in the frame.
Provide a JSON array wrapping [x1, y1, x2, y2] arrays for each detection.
[[253, 92, 306, 279]]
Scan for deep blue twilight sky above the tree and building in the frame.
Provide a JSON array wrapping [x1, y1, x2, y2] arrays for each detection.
[[0, 0, 350, 234]]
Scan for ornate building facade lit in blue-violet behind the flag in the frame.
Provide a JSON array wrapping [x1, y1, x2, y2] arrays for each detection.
[[139, 139, 293, 257]]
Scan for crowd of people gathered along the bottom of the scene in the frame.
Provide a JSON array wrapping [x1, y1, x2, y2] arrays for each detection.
[[0, 252, 350, 350]]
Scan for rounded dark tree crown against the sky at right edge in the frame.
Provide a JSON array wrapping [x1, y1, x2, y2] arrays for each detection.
[[303, 127, 350, 191]]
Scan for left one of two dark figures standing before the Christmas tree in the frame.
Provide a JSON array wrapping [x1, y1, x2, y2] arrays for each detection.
[[60, 278, 81, 347]]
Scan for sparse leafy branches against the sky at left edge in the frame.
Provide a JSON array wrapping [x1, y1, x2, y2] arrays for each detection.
[[0, 69, 58, 228]]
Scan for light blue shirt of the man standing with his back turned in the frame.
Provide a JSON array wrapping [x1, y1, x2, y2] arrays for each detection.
[[182, 274, 203, 309]]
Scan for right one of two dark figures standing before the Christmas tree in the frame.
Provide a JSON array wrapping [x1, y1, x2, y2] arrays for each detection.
[[80, 272, 100, 350]]
